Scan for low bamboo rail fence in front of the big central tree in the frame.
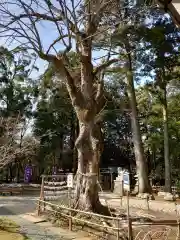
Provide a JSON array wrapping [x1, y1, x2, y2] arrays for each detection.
[[38, 200, 180, 240]]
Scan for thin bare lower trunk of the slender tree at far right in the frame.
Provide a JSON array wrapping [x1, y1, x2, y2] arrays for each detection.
[[162, 88, 171, 193]]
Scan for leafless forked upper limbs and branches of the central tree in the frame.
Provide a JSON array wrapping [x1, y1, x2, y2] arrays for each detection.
[[0, 0, 122, 106]]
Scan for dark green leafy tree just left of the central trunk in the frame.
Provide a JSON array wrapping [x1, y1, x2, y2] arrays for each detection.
[[34, 68, 75, 173]]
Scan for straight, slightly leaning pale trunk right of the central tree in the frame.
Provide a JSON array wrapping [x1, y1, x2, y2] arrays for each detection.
[[127, 68, 151, 193]]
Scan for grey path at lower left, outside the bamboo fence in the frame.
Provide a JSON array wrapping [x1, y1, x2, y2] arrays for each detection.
[[0, 196, 79, 240]]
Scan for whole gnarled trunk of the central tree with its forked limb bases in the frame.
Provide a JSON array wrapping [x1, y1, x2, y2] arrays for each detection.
[[41, 33, 108, 214]]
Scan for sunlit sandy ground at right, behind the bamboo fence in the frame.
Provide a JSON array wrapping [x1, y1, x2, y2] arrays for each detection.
[[98, 193, 180, 240]]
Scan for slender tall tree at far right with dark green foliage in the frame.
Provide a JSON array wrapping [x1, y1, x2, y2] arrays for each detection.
[[136, 17, 179, 192]]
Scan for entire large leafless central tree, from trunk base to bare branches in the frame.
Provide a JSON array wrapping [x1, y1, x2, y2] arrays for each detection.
[[0, 0, 123, 211]]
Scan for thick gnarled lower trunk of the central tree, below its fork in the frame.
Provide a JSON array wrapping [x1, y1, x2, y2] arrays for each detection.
[[75, 121, 102, 212]]
